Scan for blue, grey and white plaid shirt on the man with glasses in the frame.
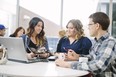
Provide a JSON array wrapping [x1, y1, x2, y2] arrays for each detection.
[[71, 33, 116, 77]]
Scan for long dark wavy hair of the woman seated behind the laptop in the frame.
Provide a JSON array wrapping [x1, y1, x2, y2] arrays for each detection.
[[27, 17, 45, 46]]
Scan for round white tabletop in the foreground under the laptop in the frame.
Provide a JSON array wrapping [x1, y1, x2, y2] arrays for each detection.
[[0, 61, 89, 77]]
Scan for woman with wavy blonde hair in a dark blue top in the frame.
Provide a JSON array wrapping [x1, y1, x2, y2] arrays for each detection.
[[56, 19, 92, 60]]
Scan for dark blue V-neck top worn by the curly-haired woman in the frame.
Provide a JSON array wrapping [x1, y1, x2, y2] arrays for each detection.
[[56, 37, 92, 55]]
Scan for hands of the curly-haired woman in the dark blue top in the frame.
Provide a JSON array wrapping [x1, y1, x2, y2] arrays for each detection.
[[65, 49, 79, 61]]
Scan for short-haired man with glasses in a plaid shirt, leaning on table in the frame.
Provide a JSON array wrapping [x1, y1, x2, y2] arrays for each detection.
[[55, 12, 116, 77]]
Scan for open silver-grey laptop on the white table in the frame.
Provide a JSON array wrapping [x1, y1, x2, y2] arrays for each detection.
[[0, 37, 48, 63]]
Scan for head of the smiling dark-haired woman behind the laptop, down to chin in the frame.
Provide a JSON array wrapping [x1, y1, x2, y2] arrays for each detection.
[[27, 17, 45, 37]]
